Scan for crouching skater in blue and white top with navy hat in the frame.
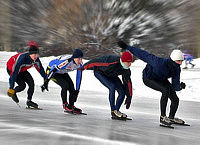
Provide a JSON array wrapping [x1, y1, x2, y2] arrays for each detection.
[[41, 49, 83, 114]]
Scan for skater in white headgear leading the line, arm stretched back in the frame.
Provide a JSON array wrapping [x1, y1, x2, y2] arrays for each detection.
[[118, 41, 186, 125]]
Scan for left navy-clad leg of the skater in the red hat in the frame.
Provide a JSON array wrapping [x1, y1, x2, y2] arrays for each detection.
[[94, 71, 116, 111]]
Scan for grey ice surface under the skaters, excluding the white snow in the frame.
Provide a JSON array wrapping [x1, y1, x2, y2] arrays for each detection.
[[0, 82, 200, 145]]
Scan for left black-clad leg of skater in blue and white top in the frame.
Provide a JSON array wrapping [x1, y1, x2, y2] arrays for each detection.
[[53, 74, 69, 104]]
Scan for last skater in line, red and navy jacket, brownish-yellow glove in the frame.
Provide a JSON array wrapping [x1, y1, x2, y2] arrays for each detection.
[[7, 41, 46, 108]]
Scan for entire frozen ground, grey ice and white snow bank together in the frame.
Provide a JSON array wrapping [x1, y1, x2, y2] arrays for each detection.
[[0, 52, 200, 145]]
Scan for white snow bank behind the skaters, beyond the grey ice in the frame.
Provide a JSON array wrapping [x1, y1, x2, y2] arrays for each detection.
[[0, 51, 200, 102]]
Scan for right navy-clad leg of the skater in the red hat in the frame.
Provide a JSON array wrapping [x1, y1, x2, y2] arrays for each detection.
[[114, 77, 125, 111]]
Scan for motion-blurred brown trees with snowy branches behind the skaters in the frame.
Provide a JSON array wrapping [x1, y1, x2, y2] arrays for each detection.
[[0, 0, 200, 58]]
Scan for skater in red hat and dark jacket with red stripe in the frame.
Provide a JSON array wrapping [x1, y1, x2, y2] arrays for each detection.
[[82, 52, 133, 118]]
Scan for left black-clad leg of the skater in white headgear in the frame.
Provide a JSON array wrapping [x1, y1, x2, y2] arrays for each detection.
[[143, 78, 170, 116]]
